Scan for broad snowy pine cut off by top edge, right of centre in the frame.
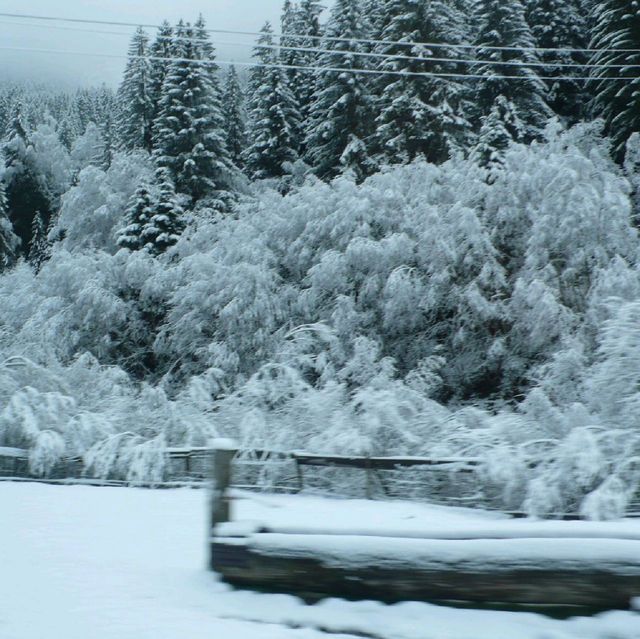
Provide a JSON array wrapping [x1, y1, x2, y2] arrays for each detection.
[[375, 0, 471, 163]]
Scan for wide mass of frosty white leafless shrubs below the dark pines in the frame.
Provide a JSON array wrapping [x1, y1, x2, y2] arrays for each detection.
[[0, 126, 640, 517]]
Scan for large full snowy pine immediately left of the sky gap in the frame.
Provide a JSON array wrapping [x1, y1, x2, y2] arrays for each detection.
[[154, 19, 235, 211]]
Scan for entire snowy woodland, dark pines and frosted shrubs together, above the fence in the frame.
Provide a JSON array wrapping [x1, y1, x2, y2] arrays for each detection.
[[0, 0, 640, 519]]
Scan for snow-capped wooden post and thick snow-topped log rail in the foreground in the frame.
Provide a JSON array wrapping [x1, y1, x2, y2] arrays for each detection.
[[209, 442, 640, 613]]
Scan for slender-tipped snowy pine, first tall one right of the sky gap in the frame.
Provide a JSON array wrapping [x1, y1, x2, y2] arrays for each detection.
[[246, 22, 301, 179]]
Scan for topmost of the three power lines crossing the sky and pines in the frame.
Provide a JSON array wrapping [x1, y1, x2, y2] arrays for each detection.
[[0, 12, 640, 53]]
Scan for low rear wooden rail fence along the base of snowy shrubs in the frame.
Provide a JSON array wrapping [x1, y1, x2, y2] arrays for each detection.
[[0, 447, 640, 518]]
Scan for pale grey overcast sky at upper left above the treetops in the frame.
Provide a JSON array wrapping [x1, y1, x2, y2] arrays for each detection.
[[0, 0, 330, 86]]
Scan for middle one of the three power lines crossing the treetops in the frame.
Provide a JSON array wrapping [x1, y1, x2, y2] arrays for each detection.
[[0, 14, 640, 69]]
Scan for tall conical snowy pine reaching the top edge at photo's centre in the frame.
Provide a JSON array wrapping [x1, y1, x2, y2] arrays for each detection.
[[306, 0, 374, 180]]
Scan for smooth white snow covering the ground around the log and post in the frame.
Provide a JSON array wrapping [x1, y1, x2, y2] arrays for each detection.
[[0, 483, 640, 639]]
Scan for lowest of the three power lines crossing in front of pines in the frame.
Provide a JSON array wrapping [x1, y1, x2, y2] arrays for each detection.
[[0, 46, 640, 82]]
